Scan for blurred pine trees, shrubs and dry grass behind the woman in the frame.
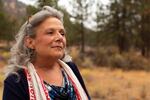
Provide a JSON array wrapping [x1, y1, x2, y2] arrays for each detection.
[[0, 0, 150, 100]]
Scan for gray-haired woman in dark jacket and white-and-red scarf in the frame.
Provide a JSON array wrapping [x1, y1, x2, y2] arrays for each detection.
[[3, 6, 90, 100]]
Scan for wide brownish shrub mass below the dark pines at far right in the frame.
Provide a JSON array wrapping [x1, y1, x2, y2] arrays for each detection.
[[93, 47, 150, 71]]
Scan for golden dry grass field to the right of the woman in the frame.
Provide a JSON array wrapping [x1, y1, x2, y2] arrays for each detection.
[[81, 68, 150, 100]]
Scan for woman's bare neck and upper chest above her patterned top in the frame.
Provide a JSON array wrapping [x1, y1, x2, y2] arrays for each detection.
[[33, 59, 63, 86]]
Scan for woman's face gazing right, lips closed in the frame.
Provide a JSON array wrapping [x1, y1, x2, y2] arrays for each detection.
[[30, 17, 66, 59]]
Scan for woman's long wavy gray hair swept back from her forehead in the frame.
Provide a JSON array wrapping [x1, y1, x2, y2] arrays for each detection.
[[7, 6, 71, 75]]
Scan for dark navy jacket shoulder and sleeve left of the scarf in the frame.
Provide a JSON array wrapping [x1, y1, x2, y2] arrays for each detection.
[[3, 69, 29, 100]]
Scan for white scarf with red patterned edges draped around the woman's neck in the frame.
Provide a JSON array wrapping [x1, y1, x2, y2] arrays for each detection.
[[25, 60, 88, 100]]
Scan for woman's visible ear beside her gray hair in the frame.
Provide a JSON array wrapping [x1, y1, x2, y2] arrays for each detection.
[[24, 36, 35, 49]]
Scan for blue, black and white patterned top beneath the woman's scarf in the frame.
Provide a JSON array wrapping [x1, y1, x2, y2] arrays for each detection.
[[44, 69, 77, 100]]
